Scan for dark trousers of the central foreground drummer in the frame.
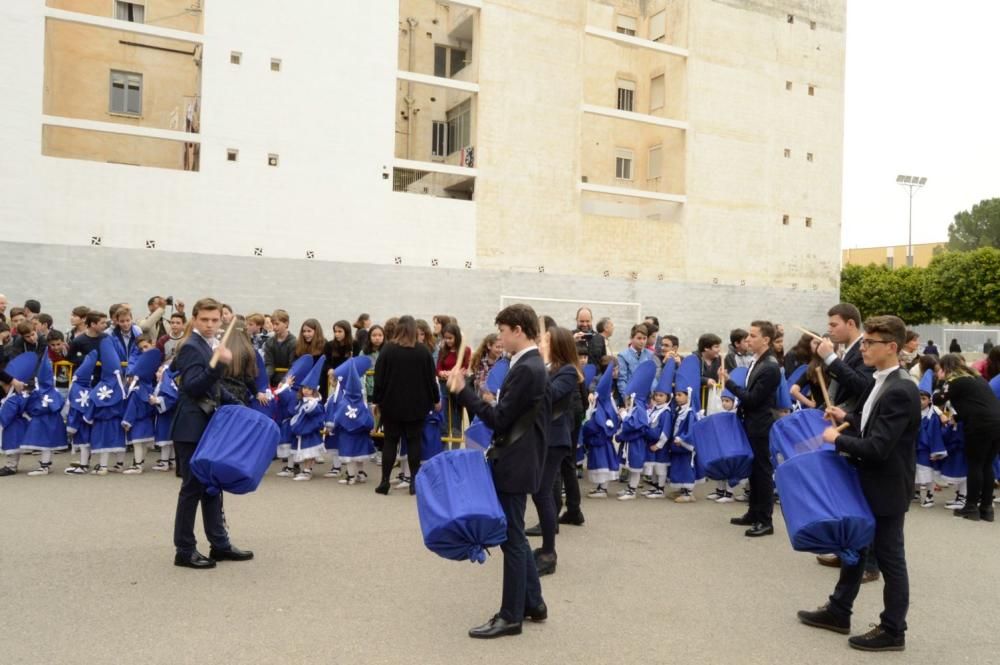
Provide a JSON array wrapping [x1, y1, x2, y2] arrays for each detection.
[[497, 492, 542, 623]]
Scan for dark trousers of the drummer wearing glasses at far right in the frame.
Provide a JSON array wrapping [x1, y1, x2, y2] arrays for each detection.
[[830, 513, 910, 636]]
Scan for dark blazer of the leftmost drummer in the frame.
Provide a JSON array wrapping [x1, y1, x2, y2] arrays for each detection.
[[170, 332, 240, 443]]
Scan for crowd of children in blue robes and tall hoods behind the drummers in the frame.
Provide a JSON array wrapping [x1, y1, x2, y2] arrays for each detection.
[[0, 299, 1000, 509]]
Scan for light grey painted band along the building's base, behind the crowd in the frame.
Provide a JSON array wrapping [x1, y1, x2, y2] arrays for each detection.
[[0, 242, 838, 349]]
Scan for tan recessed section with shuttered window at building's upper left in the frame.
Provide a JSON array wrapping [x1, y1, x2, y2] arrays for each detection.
[[42, 0, 202, 171]]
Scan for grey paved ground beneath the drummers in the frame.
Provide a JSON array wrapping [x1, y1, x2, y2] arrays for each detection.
[[0, 455, 1000, 665]]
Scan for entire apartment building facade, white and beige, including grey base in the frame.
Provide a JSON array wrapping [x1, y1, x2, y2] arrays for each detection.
[[0, 0, 845, 344]]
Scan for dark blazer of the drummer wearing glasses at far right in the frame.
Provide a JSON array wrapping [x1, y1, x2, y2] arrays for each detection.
[[836, 370, 920, 516]]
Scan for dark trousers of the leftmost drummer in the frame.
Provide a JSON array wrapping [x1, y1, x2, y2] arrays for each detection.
[[174, 441, 232, 554]]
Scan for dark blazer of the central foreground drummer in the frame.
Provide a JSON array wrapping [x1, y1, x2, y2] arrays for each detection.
[[458, 350, 551, 494]]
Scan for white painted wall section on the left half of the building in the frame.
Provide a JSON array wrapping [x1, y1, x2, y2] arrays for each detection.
[[0, 0, 476, 267]]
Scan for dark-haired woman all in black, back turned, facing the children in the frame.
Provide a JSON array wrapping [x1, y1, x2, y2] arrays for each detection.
[[372, 316, 441, 494]]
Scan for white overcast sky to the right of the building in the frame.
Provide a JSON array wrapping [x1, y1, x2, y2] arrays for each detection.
[[841, 0, 1000, 248]]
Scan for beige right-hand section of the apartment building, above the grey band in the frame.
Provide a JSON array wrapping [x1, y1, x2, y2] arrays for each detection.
[[394, 0, 845, 290]]
